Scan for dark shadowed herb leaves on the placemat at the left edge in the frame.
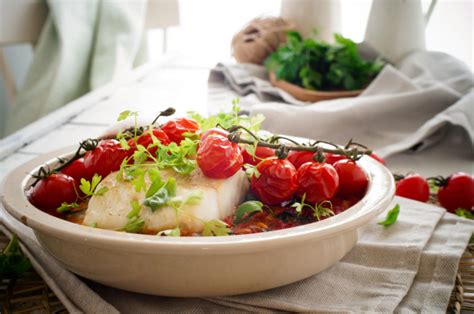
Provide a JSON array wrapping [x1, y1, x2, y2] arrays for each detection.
[[0, 235, 31, 278]]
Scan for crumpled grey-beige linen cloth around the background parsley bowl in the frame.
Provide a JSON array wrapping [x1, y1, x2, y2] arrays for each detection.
[[209, 52, 474, 157]]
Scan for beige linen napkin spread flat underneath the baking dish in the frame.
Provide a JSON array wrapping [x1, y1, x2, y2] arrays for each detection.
[[0, 197, 474, 313]]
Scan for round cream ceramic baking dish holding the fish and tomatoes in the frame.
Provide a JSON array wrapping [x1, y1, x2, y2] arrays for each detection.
[[1, 148, 395, 297]]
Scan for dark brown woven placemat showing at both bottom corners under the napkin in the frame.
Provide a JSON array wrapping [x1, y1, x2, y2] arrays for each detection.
[[0, 228, 474, 314]]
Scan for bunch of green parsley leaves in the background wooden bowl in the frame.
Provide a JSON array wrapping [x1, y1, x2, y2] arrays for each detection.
[[265, 31, 383, 91]]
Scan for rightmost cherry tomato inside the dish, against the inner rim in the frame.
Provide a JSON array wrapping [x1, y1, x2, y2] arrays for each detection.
[[333, 159, 369, 198]]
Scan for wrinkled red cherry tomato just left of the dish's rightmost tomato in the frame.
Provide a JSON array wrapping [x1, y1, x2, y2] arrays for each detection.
[[296, 161, 339, 204]]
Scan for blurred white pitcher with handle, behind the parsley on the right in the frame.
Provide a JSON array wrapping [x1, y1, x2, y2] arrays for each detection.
[[364, 0, 436, 62]]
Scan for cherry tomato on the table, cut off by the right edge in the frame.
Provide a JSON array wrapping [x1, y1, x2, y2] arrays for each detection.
[[438, 172, 474, 213]]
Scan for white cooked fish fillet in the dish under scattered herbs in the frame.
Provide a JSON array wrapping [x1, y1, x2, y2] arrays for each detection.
[[83, 169, 248, 234]]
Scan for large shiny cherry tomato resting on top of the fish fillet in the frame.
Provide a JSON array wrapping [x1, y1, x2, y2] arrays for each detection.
[[196, 135, 244, 179]]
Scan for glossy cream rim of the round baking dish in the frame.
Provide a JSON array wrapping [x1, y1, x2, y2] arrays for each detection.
[[0, 146, 395, 254]]
